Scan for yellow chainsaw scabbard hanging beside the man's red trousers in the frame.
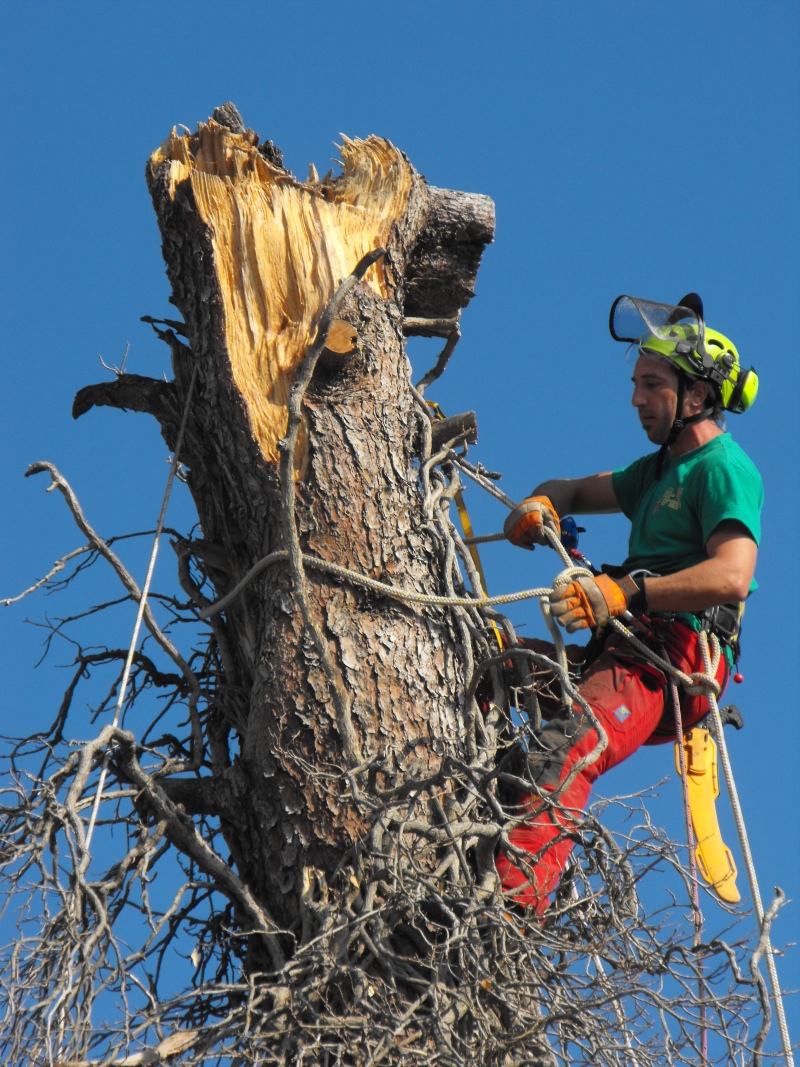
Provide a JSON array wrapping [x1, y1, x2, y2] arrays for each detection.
[[675, 728, 741, 904]]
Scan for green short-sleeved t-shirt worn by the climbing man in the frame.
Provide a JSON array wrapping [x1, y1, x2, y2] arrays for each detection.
[[611, 433, 764, 591]]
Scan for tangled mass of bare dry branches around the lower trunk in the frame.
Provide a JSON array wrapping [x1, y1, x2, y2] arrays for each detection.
[[0, 311, 771, 1067]]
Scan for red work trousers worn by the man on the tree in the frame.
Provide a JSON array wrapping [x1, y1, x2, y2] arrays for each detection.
[[495, 622, 729, 914]]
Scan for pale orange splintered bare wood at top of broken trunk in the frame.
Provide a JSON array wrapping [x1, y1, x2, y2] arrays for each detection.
[[149, 120, 412, 474]]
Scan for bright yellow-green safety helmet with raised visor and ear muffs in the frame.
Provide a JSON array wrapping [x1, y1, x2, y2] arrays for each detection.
[[609, 292, 758, 414]]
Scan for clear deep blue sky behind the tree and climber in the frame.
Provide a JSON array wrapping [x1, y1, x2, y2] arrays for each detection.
[[0, 0, 800, 1040]]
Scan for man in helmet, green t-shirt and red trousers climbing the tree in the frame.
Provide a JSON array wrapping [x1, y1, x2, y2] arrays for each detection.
[[496, 293, 763, 913]]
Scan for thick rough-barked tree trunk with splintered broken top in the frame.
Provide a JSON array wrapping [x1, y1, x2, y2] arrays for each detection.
[[81, 109, 494, 926]]
